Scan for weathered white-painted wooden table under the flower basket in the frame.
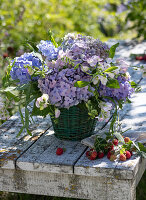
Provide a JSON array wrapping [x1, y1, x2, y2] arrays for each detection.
[[0, 41, 146, 200]]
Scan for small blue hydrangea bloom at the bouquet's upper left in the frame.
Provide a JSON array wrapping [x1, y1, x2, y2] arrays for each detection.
[[37, 40, 59, 60]]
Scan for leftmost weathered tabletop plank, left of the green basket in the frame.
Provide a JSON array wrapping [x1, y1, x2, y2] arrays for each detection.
[[0, 113, 51, 169]]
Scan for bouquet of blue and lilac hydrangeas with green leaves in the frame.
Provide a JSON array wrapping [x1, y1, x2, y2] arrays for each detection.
[[3, 33, 136, 139]]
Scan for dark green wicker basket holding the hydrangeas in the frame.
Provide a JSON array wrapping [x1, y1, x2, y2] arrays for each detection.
[[51, 106, 96, 141]]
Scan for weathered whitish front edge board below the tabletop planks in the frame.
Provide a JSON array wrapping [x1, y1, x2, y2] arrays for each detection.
[[0, 169, 136, 200]]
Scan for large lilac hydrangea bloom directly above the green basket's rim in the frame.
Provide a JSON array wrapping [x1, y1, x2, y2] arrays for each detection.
[[38, 68, 93, 108]]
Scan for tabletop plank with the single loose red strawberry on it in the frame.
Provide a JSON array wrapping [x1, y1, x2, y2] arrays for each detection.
[[16, 128, 86, 174]]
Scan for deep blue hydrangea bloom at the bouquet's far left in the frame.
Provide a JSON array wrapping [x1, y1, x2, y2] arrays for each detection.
[[10, 53, 42, 85]]
